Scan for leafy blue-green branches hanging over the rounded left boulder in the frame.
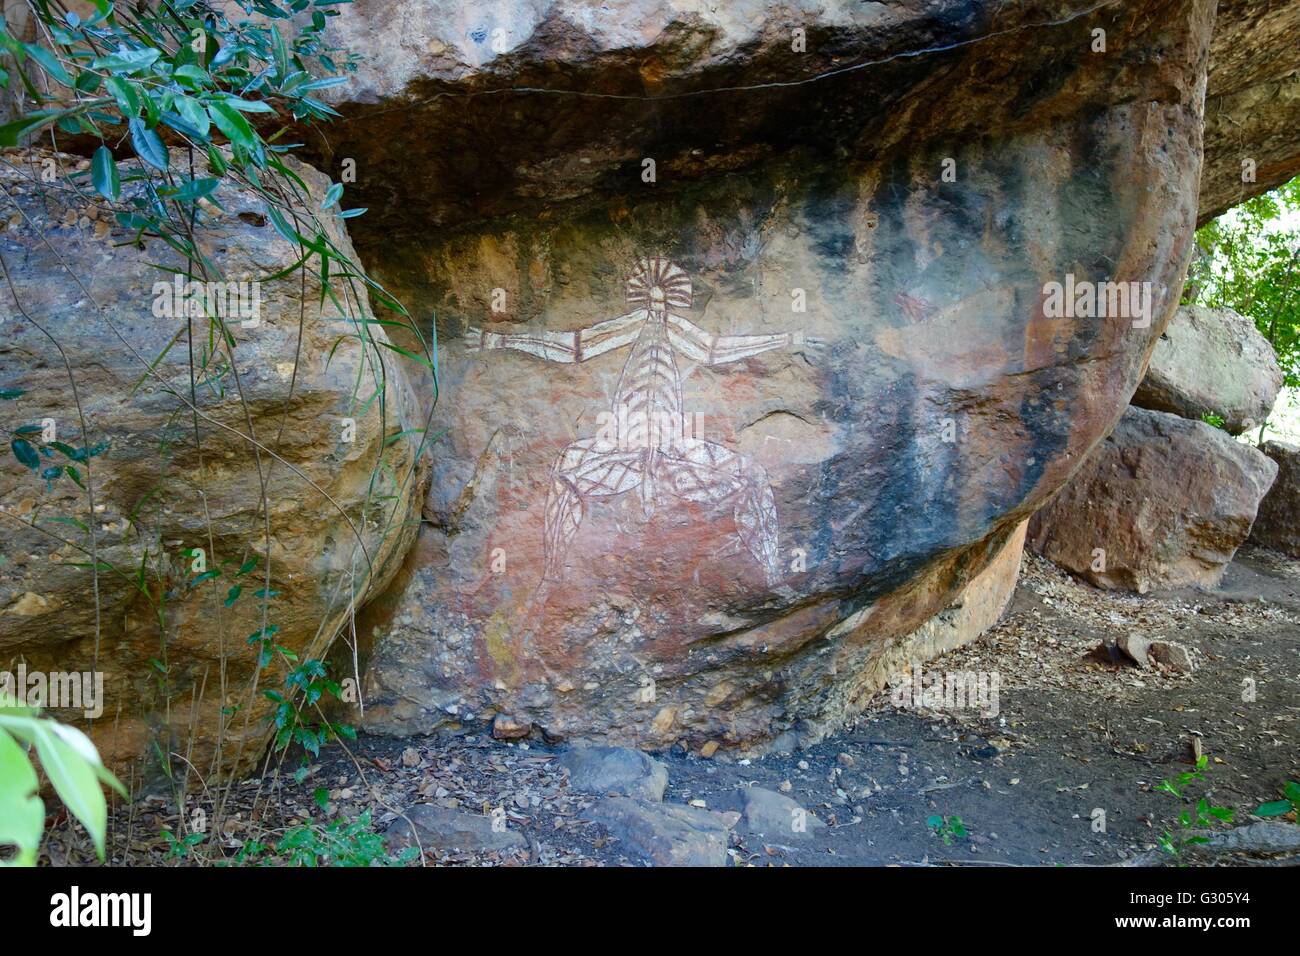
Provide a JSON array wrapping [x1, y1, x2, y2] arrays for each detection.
[[0, 0, 434, 816]]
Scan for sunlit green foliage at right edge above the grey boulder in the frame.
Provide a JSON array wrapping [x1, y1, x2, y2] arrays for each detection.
[[1184, 178, 1300, 388]]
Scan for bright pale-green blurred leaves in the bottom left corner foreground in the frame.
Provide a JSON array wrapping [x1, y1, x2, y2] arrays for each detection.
[[0, 692, 126, 866]]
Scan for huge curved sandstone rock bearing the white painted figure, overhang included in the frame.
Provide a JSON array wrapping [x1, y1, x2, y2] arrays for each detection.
[[351, 3, 1210, 748]]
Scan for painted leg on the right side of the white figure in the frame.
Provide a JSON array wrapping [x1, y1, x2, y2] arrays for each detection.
[[660, 438, 780, 584]]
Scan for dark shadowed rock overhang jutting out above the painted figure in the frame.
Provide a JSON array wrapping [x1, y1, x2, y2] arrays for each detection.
[[306, 0, 1204, 243]]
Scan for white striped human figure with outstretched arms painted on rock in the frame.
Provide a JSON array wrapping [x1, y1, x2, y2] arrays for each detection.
[[464, 256, 820, 585]]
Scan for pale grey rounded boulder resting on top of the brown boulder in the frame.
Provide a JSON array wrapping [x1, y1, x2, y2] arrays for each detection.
[[1132, 306, 1283, 434]]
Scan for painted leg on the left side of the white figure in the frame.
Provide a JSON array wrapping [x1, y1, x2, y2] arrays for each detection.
[[543, 438, 645, 581]]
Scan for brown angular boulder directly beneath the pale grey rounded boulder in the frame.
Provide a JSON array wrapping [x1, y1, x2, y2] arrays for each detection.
[[1028, 408, 1278, 593]]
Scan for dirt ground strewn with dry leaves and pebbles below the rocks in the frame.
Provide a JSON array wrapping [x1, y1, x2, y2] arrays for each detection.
[[46, 549, 1300, 866]]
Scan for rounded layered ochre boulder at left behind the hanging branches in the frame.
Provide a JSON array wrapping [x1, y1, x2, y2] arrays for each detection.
[[0, 152, 424, 773]]
